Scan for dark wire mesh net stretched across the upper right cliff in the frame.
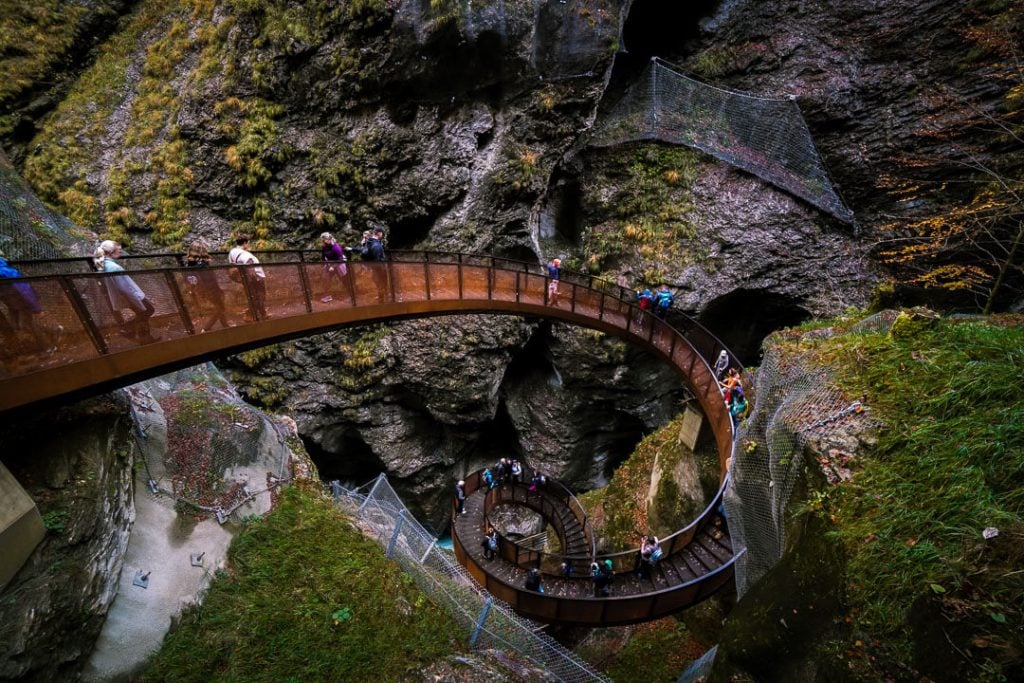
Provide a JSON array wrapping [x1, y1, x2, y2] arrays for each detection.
[[584, 59, 853, 223]]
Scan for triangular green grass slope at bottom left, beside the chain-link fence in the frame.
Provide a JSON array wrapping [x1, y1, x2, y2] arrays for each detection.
[[142, 483, 466, 682]]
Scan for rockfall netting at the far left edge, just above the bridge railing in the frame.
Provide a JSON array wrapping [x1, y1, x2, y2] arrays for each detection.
[[0, 153, 78, 261]]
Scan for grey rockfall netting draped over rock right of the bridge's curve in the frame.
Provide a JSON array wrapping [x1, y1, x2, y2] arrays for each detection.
[[724, 311, 895, 597]]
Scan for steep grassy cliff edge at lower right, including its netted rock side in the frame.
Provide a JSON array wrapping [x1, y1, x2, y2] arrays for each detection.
[[712, 311, 1024, 681]]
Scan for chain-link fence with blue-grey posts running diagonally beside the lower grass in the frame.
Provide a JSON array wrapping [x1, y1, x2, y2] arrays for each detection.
[[332, 474, 609, 682]]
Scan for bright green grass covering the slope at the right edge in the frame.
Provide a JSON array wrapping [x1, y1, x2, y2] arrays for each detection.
[[779, 316, 1024, 680]]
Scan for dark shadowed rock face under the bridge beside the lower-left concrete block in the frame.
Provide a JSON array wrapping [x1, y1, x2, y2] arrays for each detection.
[[0, 398, 135, 681]]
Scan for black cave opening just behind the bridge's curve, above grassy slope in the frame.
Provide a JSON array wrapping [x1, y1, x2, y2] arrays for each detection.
[[697, 289, 811, 366]]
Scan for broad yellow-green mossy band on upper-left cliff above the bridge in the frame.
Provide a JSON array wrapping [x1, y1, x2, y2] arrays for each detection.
[[25, 0, 213, 246]]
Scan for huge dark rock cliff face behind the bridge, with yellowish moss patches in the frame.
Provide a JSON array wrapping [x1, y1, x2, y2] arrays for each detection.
[[5, 0, 1015, 557]]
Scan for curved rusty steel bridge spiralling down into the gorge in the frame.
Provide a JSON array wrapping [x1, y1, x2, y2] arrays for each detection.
[[0, 251, 735, 625]]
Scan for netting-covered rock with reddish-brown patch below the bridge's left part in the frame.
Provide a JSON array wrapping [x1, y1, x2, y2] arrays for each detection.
[[125, 366, 294, 521]]
